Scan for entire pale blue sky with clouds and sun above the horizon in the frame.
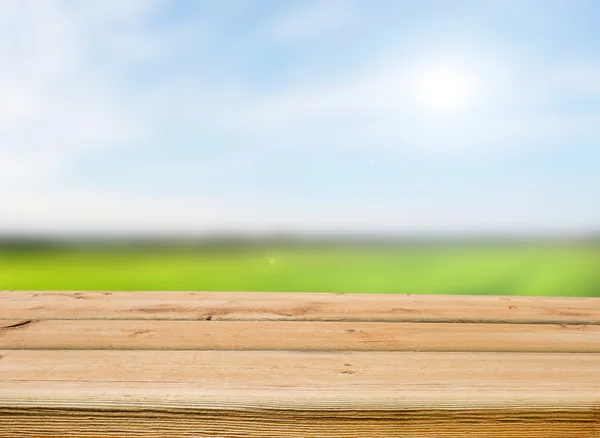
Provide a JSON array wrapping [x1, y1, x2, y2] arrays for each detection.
[[0, 0, 600, 234]]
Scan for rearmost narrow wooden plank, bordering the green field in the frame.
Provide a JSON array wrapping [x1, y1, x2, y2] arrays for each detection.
[[0, 291, 600, 324]]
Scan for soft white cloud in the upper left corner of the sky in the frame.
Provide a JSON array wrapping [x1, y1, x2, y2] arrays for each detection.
[[0, 0, 145, 177]]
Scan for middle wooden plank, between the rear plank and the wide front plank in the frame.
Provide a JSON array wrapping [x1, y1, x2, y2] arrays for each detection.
[[0, 320, 600, 352]]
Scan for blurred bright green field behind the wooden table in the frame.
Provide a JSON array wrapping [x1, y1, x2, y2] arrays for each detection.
[[0, 243, 600, 296]]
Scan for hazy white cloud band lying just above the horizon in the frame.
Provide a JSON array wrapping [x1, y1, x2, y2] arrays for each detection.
[[0, 185, 600, 236]]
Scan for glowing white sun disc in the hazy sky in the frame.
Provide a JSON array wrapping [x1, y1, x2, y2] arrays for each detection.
[[414, 65, 477, 112]]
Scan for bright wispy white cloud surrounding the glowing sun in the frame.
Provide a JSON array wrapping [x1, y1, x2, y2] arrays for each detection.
[[219, 47, 600, 159]]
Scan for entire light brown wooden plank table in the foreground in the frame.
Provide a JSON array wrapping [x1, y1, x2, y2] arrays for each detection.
[[0, 291, 600, 438]]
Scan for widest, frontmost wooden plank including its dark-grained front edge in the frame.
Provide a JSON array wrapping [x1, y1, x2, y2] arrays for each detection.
[[0, 350, 600, 438]]
